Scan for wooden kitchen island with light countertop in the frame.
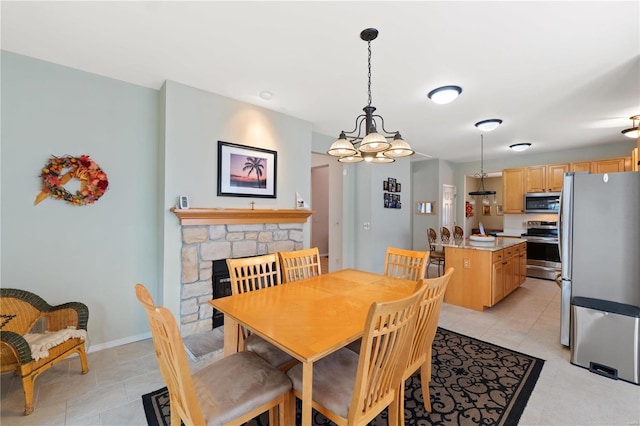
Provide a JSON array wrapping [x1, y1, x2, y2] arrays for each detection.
[[444, 237, 527, 311]]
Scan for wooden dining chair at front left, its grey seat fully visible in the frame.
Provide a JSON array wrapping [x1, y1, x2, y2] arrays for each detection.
[[136, 284, 293, 426]]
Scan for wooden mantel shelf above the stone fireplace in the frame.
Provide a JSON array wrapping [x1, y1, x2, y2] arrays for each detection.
[[170, 207, 314, 225]]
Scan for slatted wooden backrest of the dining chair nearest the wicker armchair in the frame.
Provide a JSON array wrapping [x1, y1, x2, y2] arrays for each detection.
[[136, 284, 205, 425]]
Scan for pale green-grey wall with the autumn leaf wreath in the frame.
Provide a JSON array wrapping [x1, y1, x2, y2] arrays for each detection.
[[0, 51, 159, 345]]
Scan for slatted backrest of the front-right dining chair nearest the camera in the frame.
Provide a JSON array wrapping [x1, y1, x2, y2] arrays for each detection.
[[348, 285, 426, 424]]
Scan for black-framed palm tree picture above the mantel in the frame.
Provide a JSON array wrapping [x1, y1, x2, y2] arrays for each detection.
[[218, 141, 278, 198]]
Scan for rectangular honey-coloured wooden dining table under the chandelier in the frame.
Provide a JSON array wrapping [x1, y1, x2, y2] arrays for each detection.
[[210, 269, 416, 426]]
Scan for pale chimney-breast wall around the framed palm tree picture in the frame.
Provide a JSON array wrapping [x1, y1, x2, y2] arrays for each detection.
[[160, 81, 312, 315]]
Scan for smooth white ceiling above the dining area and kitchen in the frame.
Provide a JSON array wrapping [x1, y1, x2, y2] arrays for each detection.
[[1, 1, 640, 162]]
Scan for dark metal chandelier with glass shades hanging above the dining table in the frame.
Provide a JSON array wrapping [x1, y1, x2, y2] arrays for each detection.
[[327, 28, 414, 163]]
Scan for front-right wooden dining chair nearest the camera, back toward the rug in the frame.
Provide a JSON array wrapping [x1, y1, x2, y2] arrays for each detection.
[[287, 283, 426, 426]]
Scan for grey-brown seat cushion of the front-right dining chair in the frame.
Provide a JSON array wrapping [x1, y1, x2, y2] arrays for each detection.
[[287, 348, 359, 418]]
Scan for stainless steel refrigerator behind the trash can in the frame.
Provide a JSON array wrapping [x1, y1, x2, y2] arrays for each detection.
[[558, 172, 640, 346]]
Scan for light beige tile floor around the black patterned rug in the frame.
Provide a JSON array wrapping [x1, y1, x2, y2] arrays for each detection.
[[0, 271, 640, 426]]
